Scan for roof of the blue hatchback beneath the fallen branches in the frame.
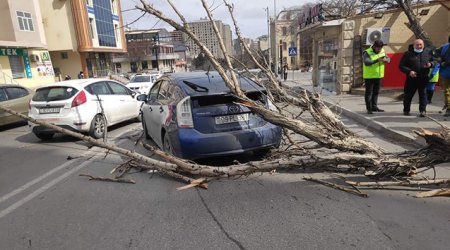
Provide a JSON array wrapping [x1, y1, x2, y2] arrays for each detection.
[[166, 71, 265, 96]]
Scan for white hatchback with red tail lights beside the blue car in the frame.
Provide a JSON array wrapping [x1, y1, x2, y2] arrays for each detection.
[[29, 79, 142, 140]]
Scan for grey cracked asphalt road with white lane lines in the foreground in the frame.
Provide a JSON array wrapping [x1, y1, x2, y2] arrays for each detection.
[[0, 117, 450, 249]]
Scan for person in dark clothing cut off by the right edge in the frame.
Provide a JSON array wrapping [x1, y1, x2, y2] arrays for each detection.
[[436, 36, 450, 116]]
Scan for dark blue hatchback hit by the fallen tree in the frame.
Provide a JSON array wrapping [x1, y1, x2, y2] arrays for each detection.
[[138, 72, 281, 159]]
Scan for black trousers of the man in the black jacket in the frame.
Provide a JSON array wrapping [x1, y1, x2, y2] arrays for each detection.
[[403, 78, 428, 112]]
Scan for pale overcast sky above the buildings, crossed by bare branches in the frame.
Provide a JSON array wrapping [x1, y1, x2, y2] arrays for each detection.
[[121, 0, 313, 38]]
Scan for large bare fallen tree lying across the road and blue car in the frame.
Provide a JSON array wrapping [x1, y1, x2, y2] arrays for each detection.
[[0, 0, 450, 196]]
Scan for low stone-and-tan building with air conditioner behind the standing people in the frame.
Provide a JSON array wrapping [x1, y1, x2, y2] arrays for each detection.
[[298, 2, 450, 94]]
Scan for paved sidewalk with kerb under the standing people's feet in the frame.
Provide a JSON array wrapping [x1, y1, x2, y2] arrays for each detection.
[[282, 73, 450, 146]]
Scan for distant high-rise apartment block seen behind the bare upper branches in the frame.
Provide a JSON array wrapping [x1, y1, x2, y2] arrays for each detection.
[[184, 19, 233, 58]]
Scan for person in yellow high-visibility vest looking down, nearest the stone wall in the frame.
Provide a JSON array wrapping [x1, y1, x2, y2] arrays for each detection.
[[363, 40, 390, 114]]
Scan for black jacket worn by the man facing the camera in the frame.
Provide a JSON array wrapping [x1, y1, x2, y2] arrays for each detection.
[[399, 45, 436, 82]]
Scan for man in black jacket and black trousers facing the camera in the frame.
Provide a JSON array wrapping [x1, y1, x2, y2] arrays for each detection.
[[399, 39, 436, 117]]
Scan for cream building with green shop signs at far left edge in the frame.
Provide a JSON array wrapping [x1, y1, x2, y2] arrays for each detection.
[[0, 0, 55, 88]]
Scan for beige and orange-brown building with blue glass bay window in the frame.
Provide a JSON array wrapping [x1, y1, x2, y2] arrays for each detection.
[[39, 0, 126, 78]]
